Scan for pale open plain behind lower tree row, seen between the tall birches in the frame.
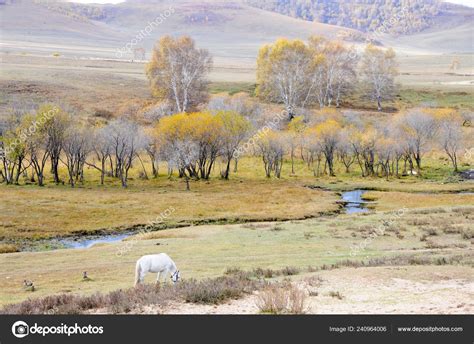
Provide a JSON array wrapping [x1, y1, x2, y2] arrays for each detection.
[[0, 52, 474, 120]]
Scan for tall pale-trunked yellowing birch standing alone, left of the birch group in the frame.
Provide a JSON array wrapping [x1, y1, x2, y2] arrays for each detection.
[[146, 36, 212, 112]]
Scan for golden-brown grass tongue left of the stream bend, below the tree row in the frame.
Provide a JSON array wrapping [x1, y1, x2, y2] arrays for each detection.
[[0, 179, 338, 239]]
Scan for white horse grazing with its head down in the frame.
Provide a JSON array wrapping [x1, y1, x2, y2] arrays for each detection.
[[135, 253, 180, 286]]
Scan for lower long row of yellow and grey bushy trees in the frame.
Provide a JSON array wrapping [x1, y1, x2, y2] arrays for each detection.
[[0, 102, 465, 188]]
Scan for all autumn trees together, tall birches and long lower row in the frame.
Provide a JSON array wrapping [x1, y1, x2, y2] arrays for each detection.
[[0, 36, 463, 188]]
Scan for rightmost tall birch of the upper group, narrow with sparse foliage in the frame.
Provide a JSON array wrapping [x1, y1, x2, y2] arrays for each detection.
[[361, 44, 398, 111]]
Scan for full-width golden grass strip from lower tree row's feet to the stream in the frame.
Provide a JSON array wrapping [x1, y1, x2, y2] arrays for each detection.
[[0, 153, 474, 245]]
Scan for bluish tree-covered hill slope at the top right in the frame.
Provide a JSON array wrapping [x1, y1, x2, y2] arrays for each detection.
[[247, 0, 474, 35]]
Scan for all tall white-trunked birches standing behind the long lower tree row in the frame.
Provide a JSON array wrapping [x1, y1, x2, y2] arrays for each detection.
[[146, 36, 398, 117]]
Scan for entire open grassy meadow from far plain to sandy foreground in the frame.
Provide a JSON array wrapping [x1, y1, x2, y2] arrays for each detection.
[[0, 21, 474, 313]]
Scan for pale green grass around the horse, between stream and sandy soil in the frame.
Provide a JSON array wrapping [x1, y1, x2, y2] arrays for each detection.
[[0, 206, 474, 305]]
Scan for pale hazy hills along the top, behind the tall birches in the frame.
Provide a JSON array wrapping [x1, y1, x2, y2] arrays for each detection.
[[0, 0, 474, 59]]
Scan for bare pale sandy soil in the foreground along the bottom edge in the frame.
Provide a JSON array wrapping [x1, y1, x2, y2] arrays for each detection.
[[116, 266, 474, 314]]
